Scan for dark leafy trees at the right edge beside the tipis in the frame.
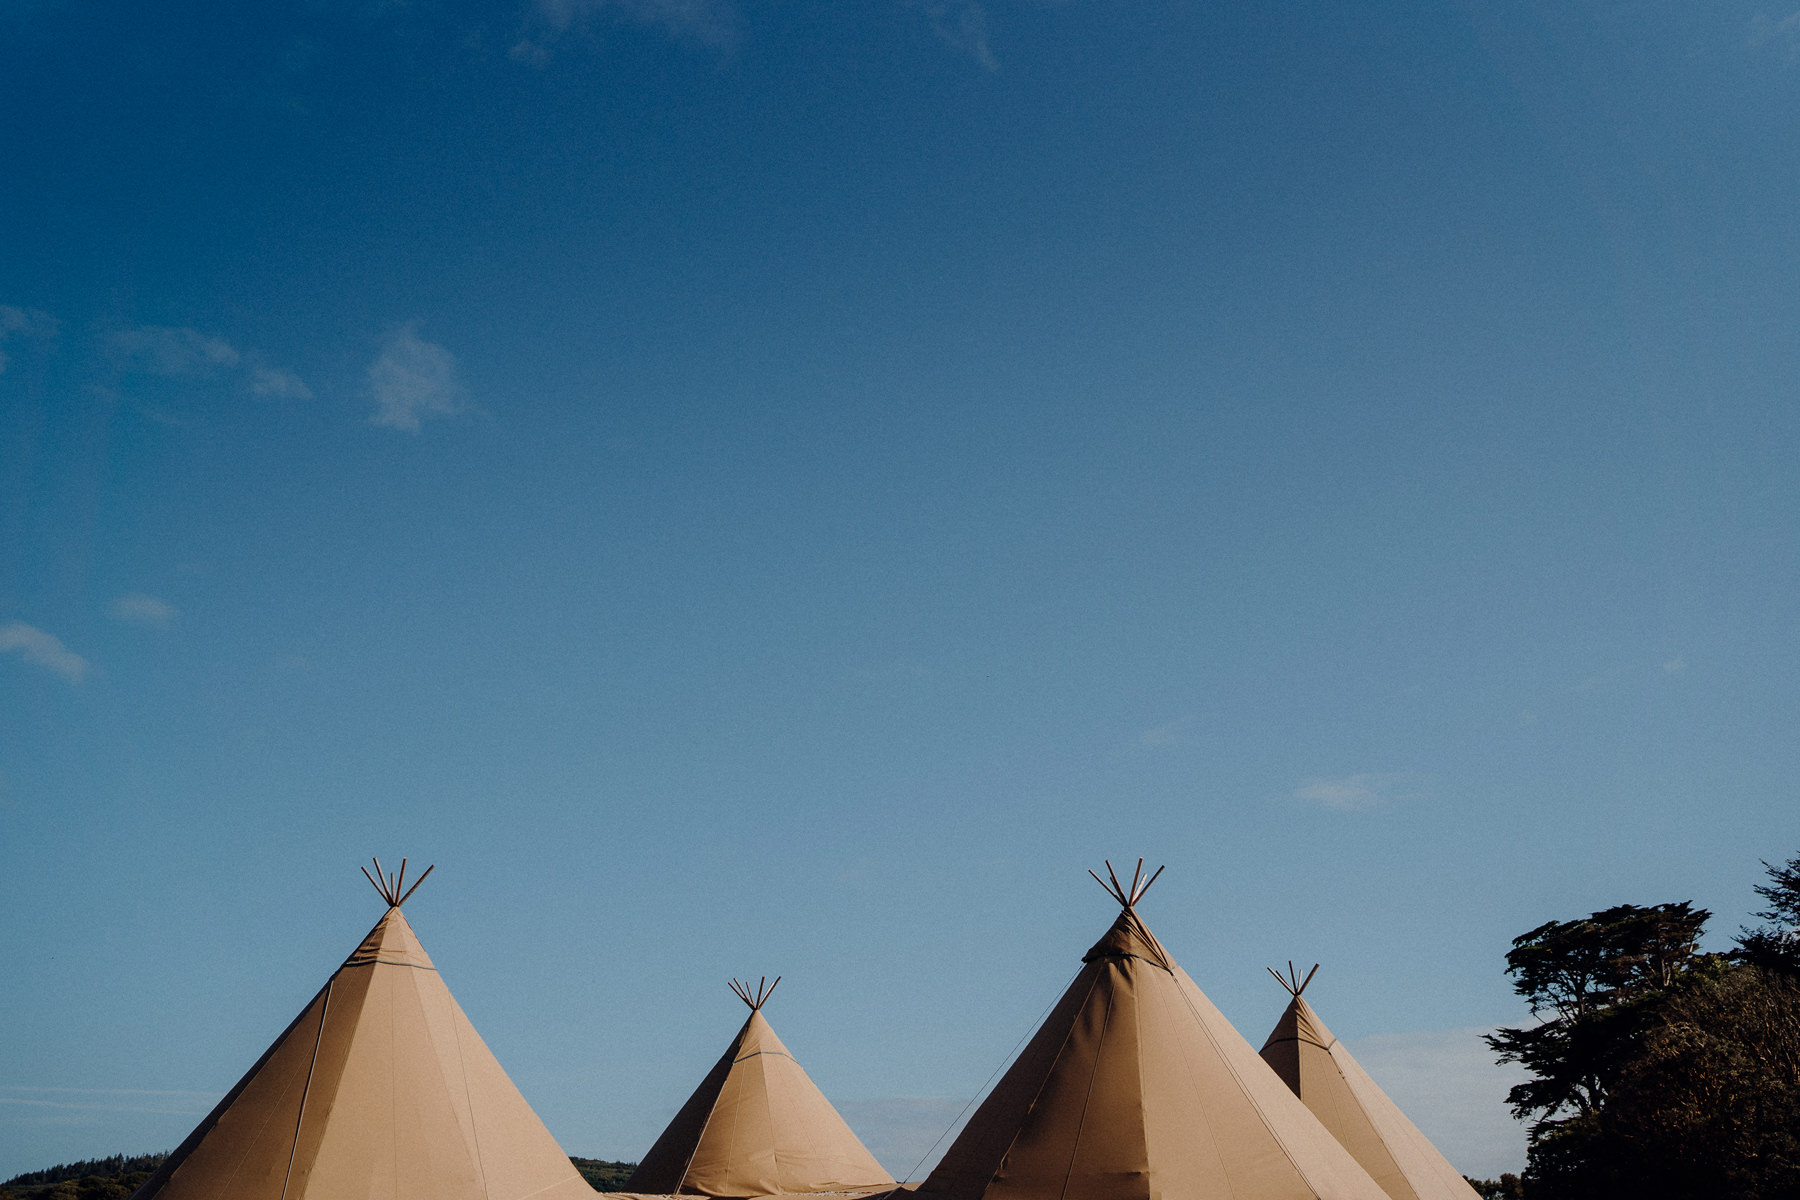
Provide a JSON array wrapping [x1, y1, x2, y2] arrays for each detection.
[[1497, 858, 1800, 1200]]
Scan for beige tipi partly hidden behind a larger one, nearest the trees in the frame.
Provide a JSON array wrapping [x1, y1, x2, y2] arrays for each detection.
[[1262, 963, 1476, 1200]]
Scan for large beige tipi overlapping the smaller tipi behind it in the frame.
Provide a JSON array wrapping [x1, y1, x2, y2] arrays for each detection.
[[918, 860, 1388, 1200]]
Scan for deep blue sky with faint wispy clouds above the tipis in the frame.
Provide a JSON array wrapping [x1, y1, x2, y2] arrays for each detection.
[[0, 0, 1800, 1177]]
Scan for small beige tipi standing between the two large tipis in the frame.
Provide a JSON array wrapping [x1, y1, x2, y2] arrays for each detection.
[[626, 977, 895, 1196]]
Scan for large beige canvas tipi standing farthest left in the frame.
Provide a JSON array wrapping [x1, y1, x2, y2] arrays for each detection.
[[133, 860, 594, 1200]]
